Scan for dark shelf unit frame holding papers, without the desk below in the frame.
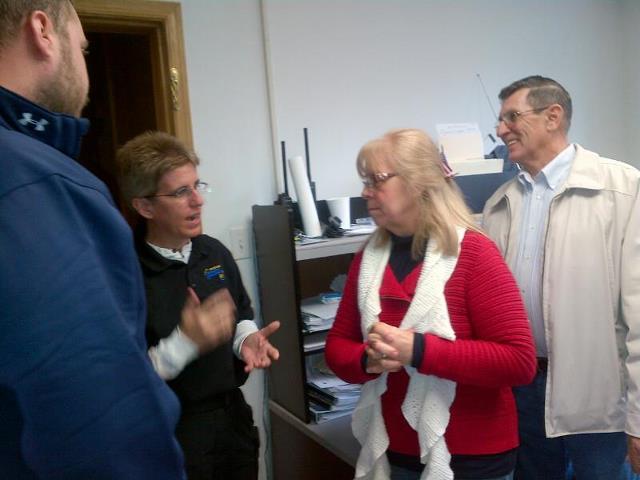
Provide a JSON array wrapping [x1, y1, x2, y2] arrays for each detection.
[[253, 205, 366, 423]]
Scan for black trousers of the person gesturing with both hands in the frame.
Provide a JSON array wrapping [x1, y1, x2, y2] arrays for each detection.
[[176, 389, 260, 480]]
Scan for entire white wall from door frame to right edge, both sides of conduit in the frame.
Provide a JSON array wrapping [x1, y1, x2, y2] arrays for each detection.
[[172, 0, 640, 478]]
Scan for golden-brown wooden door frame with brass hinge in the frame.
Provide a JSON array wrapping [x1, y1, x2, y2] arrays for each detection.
[[73, 0, 193, 147]]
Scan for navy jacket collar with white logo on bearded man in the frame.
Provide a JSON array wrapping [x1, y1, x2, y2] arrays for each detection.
[[0, 83, 89, 158]]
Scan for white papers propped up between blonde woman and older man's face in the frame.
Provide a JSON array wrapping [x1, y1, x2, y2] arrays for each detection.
[[436, 123, 503, 175]]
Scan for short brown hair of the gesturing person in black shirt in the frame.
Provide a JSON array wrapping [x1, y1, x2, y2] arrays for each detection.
[[116, 132, 200, 208]]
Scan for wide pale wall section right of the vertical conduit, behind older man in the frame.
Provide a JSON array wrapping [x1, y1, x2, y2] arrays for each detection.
[[265, 0, 638, 198]]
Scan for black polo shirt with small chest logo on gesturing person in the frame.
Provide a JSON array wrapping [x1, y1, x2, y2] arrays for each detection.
[[136, 235, 253, 406]]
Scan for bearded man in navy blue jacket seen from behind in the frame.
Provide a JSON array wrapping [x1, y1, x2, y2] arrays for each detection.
[[0, 0, 192, 480]]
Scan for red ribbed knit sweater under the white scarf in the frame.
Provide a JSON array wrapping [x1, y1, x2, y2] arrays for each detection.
[[325, 231, 536, 456]]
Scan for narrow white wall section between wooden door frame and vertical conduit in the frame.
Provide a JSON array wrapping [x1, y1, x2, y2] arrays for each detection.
[[182, 0, 275, 236]]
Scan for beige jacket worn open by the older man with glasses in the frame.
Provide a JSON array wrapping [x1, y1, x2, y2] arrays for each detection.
[[483, 145, 640, 437]]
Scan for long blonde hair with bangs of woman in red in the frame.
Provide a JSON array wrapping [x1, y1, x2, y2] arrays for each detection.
[[356, 125, 480, 258]]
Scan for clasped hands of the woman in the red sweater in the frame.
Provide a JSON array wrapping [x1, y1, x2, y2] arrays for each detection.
[[365, 322, 414, 373]]
